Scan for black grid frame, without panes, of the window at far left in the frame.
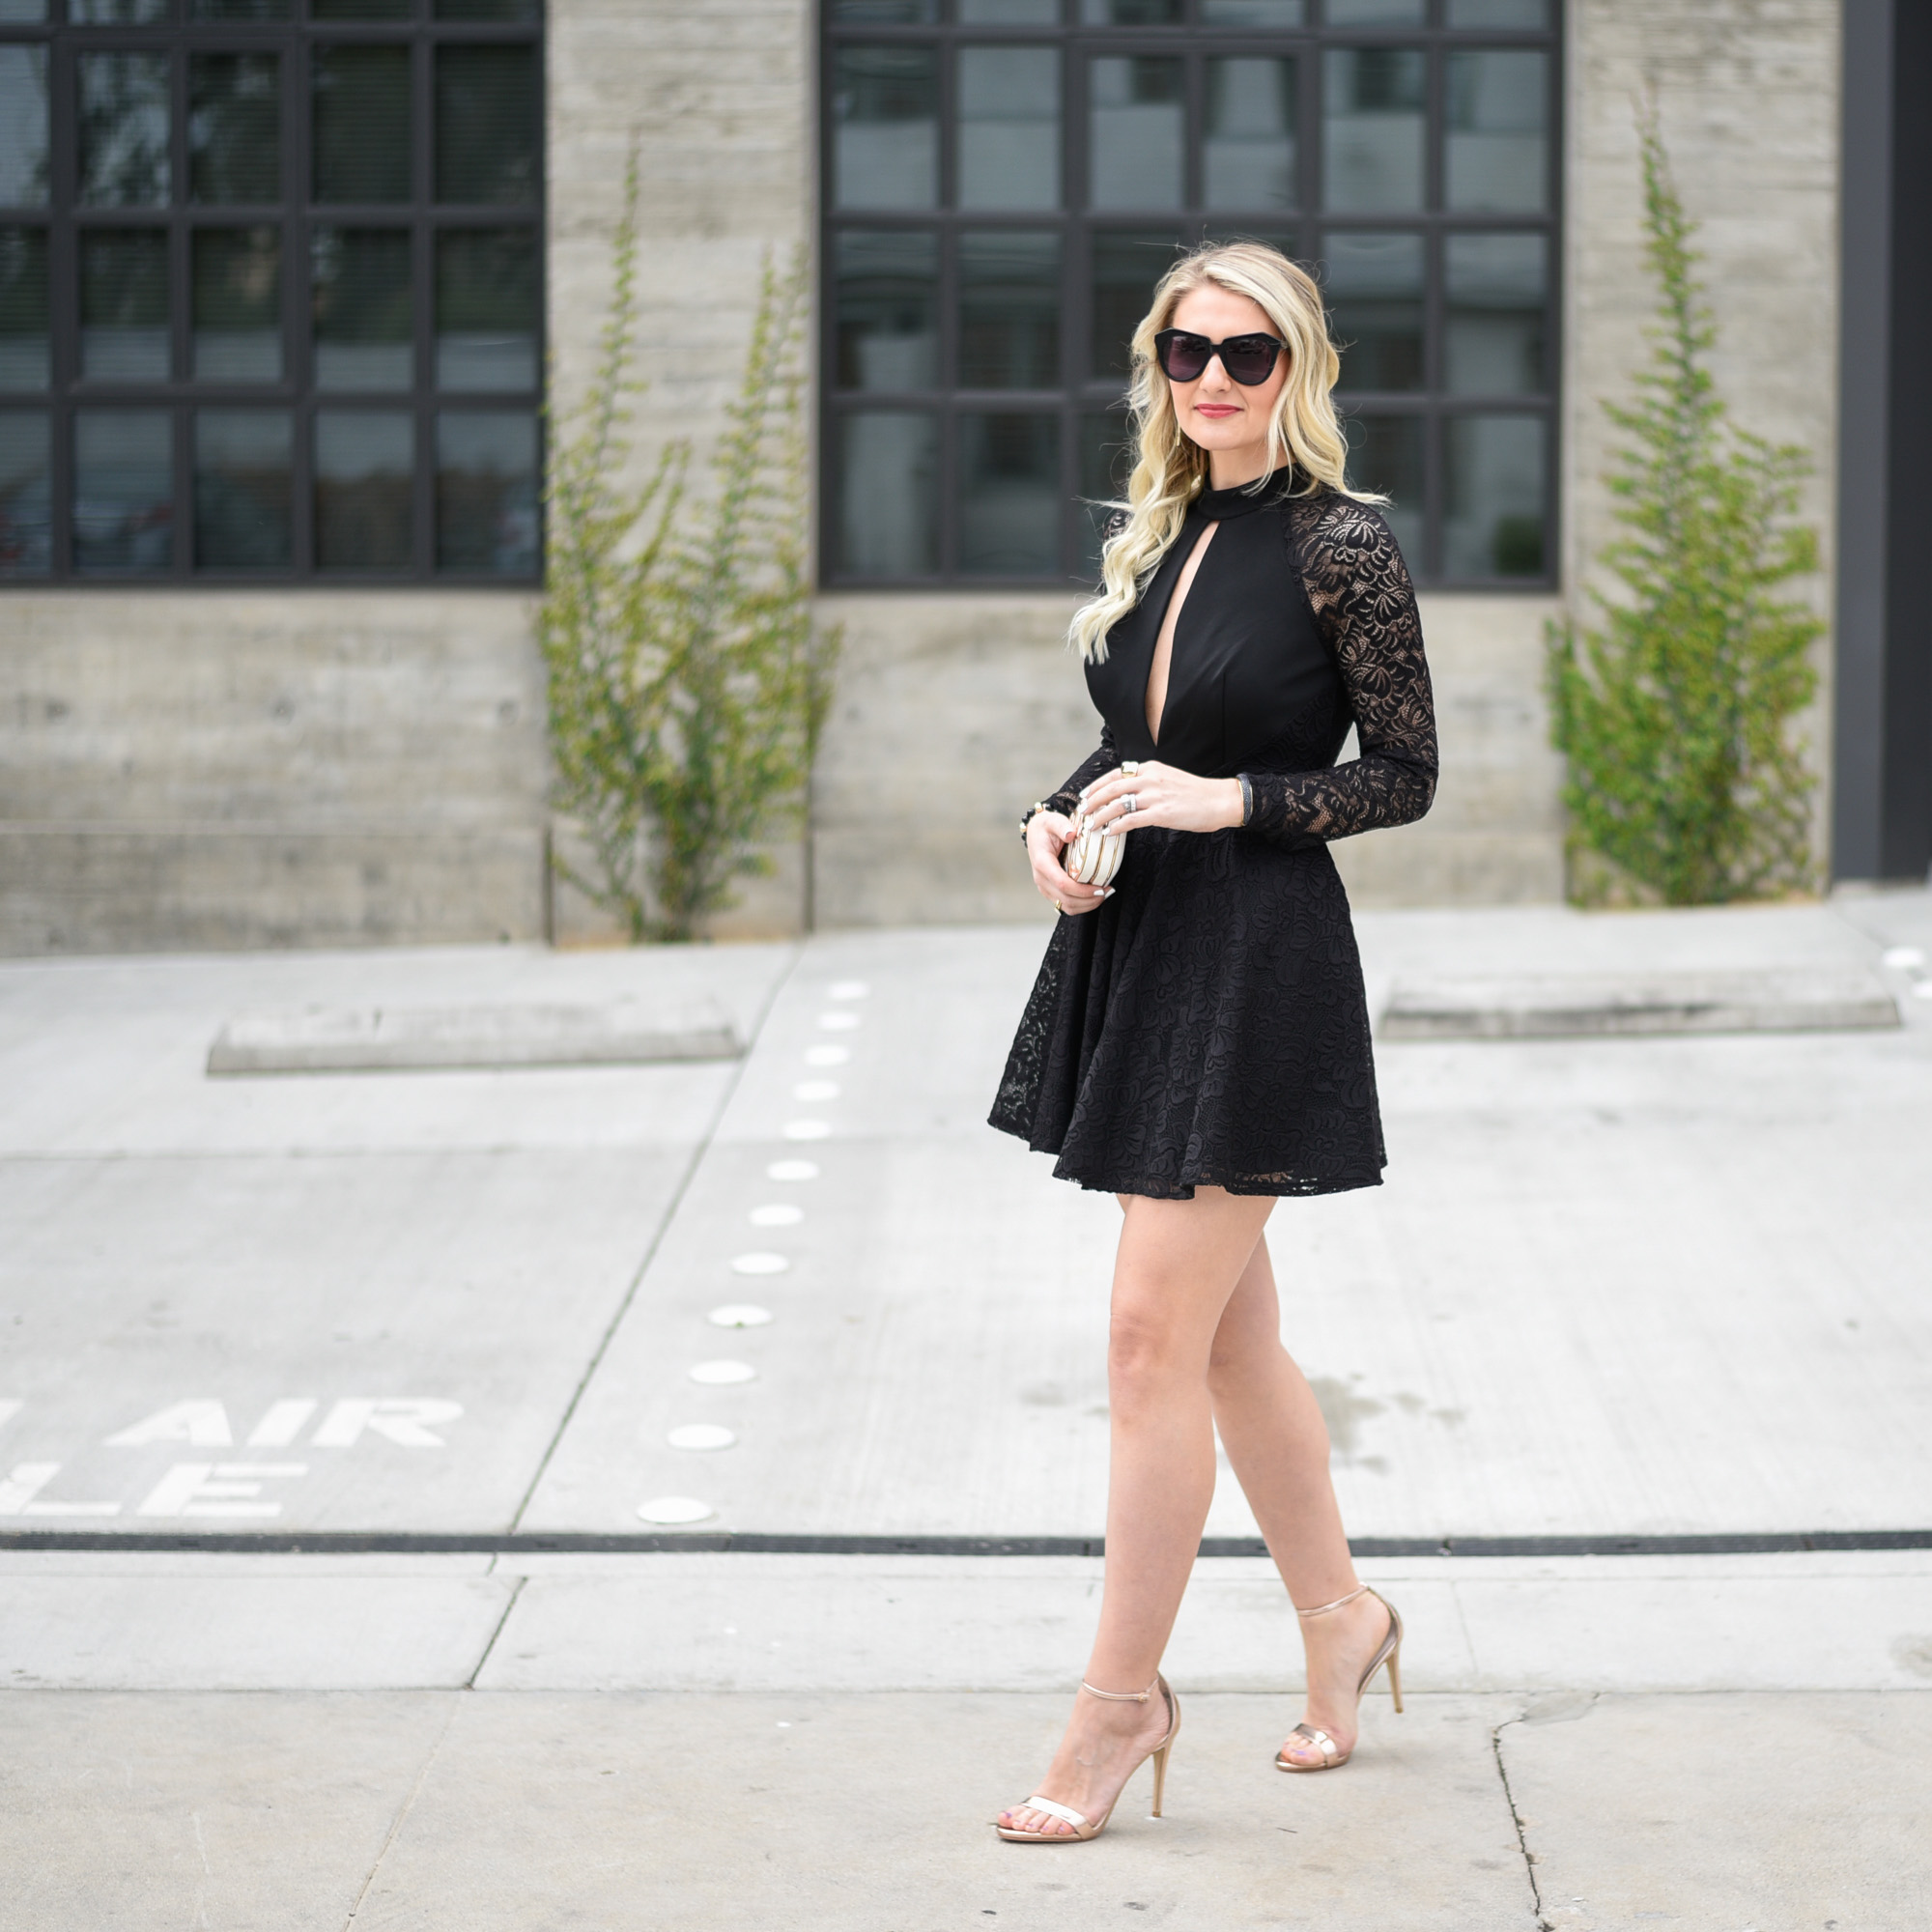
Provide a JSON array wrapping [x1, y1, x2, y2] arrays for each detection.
[[0, 0, 549, 591]]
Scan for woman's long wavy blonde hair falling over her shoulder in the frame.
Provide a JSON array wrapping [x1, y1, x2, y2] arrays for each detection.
[[1066, 242, 1387, 665]]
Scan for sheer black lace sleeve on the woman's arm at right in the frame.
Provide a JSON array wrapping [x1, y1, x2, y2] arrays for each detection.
[[1244, 497, 1437, 846]]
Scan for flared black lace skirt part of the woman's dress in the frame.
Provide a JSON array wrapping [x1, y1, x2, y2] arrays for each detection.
[[991, 827, 1383, 1200]]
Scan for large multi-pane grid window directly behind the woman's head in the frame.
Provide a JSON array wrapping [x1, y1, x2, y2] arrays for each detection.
[[821, 0, 1559, 587]]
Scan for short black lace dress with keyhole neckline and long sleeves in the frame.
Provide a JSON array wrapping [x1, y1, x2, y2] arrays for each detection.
[[991, 471, 1435, 1200]]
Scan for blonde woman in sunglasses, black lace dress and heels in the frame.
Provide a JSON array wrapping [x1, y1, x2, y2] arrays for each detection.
[[993, 243, 1435, 1843]]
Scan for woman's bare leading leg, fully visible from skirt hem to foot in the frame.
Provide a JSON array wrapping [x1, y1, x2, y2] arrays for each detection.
[[1001, 1188, 1275, 1835]]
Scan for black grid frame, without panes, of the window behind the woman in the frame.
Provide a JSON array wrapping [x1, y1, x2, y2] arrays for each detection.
[[817, 0, 1565, 595]]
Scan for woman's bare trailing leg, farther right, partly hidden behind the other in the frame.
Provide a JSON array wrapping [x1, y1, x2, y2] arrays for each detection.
[[1208, 1238, 1389, 1764]]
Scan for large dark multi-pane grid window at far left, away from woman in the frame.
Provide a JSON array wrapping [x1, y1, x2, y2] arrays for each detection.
[[0, 0, 541, 583]]
